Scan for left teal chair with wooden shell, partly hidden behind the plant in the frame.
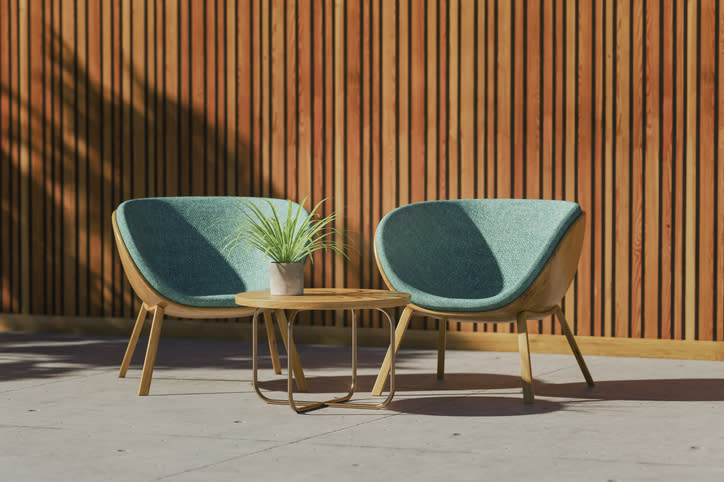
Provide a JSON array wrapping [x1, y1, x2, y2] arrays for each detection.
[[112, 197, 307, 395]]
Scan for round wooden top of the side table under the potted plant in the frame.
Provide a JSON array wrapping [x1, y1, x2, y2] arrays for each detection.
[[236, 288, 410, 310]]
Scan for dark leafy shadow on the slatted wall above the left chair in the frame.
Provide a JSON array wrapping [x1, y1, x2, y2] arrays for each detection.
[[0, 31, 251, 316]]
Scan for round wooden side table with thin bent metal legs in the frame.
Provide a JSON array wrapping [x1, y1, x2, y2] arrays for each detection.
[[236, 288, 410, 413]]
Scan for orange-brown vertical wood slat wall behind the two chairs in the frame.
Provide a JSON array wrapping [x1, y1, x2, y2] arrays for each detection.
[[0, 0, 724, 340]]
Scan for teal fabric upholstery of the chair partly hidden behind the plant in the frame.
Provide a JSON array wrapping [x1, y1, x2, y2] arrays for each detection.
[[116, 196, 308, 307]]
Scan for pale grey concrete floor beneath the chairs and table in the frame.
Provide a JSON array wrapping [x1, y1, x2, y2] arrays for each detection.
[[0, 333, 724, 481]]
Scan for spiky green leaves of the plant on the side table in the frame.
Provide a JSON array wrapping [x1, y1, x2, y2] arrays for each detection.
[[225, 198, 347, 263]]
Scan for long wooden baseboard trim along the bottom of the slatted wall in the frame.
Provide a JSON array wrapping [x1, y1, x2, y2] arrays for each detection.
[[0, 313, 724, 361]]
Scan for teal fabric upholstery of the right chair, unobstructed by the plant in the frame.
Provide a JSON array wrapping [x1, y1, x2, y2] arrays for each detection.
[[375, 199, 582, 312]]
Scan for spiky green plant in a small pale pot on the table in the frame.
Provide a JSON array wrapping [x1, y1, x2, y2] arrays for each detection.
[[226, 198, 347, 295]]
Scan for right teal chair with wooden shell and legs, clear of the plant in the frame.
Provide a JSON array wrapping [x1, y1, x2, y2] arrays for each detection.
[[372, 199, 593, 403]]
